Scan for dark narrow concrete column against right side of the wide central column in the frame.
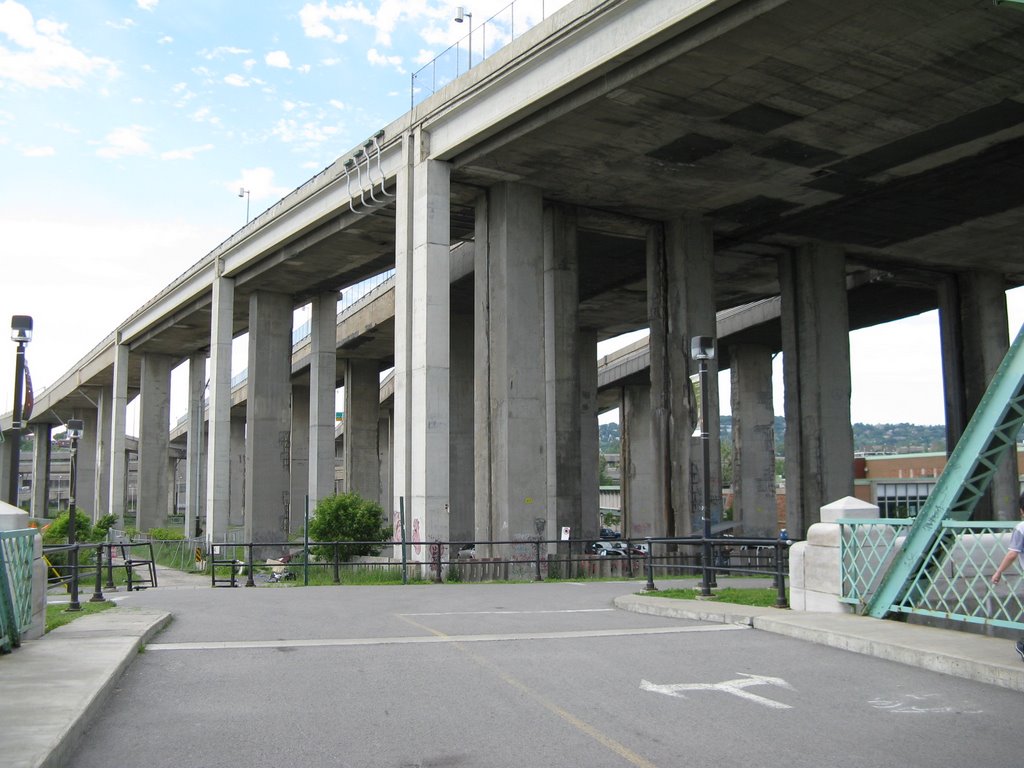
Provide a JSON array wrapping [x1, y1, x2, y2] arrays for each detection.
[[543, 206, 596, 539]]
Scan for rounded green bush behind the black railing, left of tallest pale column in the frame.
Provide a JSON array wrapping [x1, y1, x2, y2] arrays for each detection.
[[309, 493, 391, 561]]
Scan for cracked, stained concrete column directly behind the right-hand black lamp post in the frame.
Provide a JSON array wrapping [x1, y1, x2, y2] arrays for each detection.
[[665, 215, 722, 536]]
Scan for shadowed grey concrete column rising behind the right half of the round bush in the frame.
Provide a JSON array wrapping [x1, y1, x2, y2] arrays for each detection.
[[345, 359, 381, 499]]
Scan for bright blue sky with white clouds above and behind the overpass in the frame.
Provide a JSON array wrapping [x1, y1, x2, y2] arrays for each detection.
[[0, 0, 1024, 434]]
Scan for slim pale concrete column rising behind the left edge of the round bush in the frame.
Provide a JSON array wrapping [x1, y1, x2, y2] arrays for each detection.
[[308, 291, 339, 510]]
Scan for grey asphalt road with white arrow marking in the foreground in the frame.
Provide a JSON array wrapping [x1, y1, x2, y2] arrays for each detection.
[[72, 583, 1024, 768]]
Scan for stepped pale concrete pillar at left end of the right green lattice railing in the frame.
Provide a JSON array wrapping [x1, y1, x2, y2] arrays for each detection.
[[790, 496, 879, 613]]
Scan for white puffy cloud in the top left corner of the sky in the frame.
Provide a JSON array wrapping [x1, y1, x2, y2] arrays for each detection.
[[0, 0, 117, 89]]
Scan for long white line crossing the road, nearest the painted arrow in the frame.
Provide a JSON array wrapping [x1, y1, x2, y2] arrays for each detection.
[[145, 624, 750, 652]]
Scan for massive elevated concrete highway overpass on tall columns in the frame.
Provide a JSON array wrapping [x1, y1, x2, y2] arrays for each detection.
[[4, 0, 1024, 552]]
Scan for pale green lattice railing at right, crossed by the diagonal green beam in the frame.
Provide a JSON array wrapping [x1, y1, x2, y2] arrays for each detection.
[[838, 518, 1024, 630]]
